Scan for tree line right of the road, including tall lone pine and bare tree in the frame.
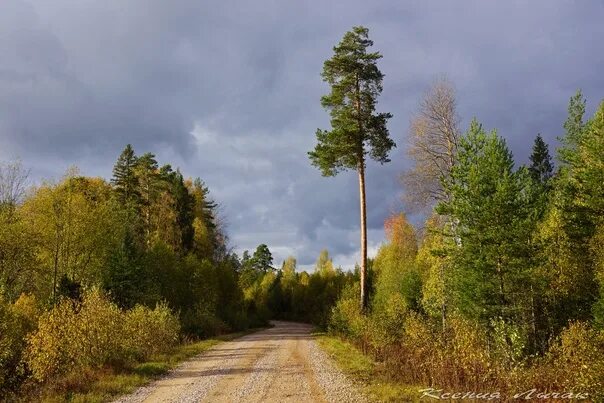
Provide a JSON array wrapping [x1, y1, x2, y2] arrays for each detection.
[[316, 27, 604, 399]]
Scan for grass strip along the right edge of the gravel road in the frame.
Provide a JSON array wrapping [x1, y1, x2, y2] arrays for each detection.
[[313, 332, 422, 402]]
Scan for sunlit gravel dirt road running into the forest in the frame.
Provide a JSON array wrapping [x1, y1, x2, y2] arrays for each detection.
[[117, 321, 365, 403]]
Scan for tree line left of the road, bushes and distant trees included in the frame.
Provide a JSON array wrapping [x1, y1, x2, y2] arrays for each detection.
[[0, 145, 356, 397]]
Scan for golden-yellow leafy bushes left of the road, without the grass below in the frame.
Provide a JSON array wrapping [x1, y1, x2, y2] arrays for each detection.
[[25, 289, 179, 381]]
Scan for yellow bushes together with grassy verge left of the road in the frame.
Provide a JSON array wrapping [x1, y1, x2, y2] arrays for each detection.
[[0, 288, 260, 402]]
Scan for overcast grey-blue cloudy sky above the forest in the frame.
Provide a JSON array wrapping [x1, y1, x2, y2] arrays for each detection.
[[0, 0, 604, 267]]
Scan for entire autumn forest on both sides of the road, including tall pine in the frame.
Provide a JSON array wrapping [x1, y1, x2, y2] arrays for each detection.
[[0, 28, 604, 399]]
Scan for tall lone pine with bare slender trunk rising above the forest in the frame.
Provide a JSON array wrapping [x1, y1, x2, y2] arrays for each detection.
[[308, 27, 396, 309]]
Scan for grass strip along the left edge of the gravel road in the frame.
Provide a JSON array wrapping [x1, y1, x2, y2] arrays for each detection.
[[21, 329, 261, 403]]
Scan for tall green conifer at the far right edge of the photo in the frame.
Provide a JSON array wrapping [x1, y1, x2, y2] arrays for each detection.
[[536, 97, 604, 335]]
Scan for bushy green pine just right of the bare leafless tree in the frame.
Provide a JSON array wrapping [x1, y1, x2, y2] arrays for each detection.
[[438, 120, 530, 323]]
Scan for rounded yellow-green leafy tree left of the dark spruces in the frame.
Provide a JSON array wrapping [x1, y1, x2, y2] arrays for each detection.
[[17, 175, 124, 300]]
